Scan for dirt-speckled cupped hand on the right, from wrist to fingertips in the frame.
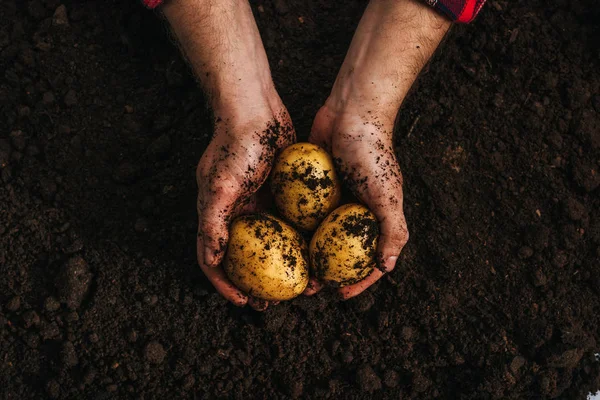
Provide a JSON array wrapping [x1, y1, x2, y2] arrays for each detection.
[[305, 105, 408, 299]]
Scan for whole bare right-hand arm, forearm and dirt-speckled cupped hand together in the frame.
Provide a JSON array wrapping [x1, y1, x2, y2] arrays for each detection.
[[305, 0, 450, 299]]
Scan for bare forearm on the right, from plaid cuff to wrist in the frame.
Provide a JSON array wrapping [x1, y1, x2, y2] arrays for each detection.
[[327, 0, 451, 120]]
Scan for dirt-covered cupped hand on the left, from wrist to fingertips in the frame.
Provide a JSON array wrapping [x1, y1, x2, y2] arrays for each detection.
[[196, 107, 296, 309]]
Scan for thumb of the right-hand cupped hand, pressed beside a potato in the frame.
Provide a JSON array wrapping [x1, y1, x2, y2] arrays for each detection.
[[375, 210, 408, 273]]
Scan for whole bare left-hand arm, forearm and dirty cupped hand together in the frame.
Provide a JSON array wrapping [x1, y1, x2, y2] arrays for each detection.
[[163, 0, 295, 310]]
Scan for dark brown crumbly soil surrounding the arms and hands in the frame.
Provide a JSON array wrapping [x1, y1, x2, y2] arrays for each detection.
[[0, 0, 600, 399]]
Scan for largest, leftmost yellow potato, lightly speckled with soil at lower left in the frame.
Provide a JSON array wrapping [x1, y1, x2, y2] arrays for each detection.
[[223, 214, 308, 300]]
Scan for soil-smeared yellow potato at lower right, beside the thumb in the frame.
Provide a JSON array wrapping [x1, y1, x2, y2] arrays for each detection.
[[310, 204, 379, 287]]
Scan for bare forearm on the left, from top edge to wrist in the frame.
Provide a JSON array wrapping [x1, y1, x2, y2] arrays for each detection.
[[163, 0, 278, 115]]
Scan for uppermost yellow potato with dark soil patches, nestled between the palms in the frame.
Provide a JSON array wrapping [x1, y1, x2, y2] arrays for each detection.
[[271, 143, 342, 231]]
